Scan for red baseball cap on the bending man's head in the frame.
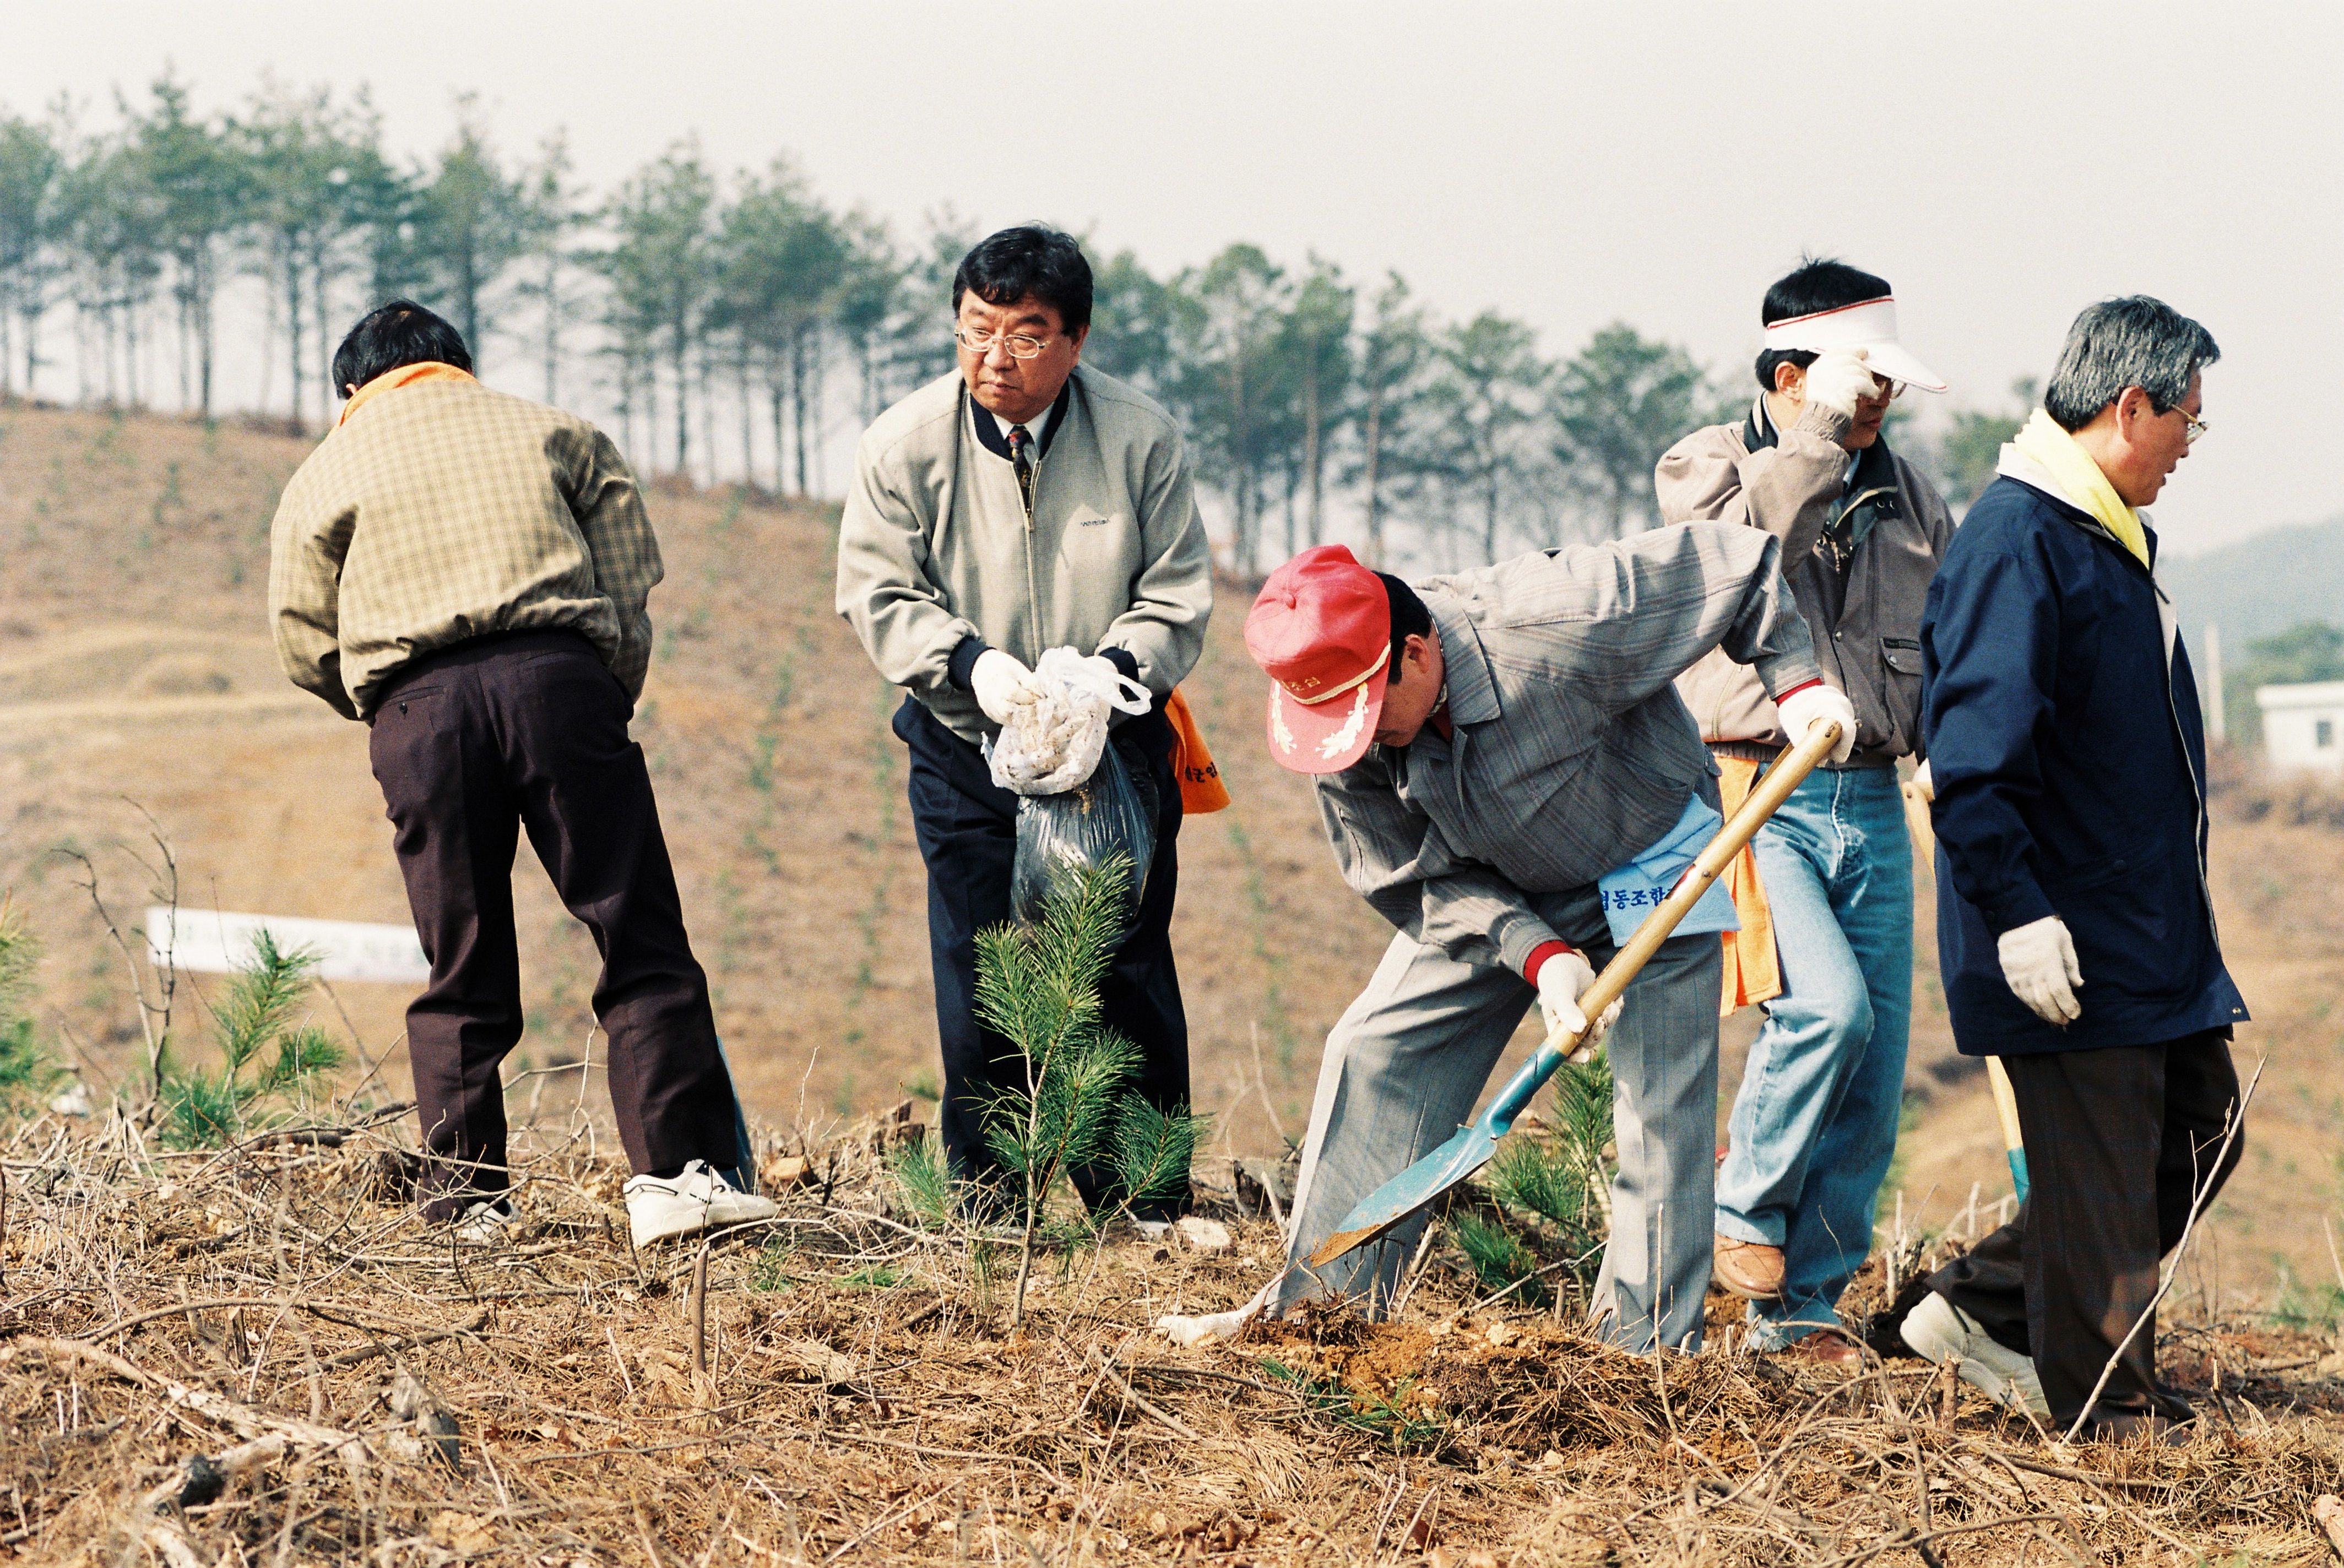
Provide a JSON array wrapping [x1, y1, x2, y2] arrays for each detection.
[[1245, 544, 1392, 773]]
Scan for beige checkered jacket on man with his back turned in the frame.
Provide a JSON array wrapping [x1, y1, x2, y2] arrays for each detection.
[[269, 379, 661, 719]]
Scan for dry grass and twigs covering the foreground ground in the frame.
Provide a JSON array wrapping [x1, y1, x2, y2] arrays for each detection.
[[0, 1087, 2344, 1568]]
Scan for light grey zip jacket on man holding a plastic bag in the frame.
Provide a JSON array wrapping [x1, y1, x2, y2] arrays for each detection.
[[837, 366, 1212, 741]]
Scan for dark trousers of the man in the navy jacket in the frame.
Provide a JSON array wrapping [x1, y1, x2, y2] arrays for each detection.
[[1929, 1029, 2245, 1430]]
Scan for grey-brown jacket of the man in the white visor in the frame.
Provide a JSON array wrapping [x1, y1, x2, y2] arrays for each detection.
[[1652, 398, 1952, 769]]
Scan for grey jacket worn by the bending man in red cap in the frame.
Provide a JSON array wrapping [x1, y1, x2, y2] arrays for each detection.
[[1317, 523, 1816, 970]]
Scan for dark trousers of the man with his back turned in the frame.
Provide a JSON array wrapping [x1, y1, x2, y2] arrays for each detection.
[[368, 633, 739, 1219]]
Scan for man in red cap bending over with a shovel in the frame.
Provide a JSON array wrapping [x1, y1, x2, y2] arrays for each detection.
[[1245, 523, 1857, 1350]]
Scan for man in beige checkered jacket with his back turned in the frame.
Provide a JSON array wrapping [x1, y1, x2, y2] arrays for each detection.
[[269, 300, 776, 1245]]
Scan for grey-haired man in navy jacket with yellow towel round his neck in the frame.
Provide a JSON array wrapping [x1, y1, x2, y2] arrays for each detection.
[[1903, 297, 2245, 1437]]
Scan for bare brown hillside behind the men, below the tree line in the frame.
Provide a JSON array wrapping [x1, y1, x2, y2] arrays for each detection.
[[0, 405, 2344, 1287]]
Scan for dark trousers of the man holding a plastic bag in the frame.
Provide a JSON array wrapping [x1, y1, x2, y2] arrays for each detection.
[[896, 698, 1189, 1219]]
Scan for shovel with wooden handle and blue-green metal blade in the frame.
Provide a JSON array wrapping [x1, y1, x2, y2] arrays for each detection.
[[1310, 724, 1840, 1268]]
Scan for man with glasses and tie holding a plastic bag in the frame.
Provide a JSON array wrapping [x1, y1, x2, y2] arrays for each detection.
[[837, 227, 1212, 1223]]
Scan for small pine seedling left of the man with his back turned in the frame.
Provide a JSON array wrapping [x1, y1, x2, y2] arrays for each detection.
[[162, 930, 342, 1148]]
